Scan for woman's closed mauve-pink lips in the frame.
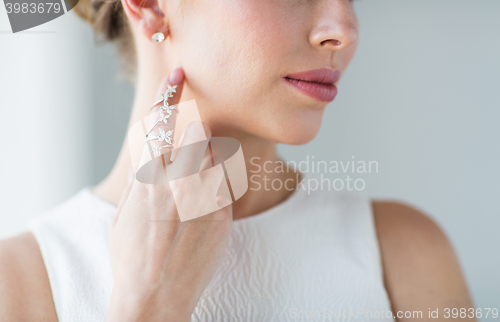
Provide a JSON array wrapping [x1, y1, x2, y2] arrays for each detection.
[[283, 68, 341, 102]]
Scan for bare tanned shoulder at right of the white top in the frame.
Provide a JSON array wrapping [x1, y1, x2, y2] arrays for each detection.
[[372, 200, 473, 318]]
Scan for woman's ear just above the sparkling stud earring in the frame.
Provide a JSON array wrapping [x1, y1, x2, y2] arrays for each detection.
[[121, 0, 168, 40]]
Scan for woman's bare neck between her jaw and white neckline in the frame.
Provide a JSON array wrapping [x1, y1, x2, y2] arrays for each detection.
[[93, 72, 298, 220]]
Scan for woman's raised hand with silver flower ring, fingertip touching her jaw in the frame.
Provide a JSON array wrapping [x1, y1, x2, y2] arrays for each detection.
[[108, 69, 233, 322]]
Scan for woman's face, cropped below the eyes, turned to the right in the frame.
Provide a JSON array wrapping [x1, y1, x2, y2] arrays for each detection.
[[164, 0, 358, 144]]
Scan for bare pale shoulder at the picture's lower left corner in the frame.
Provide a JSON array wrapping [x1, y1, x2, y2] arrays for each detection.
[[0, 232, 57, 322]]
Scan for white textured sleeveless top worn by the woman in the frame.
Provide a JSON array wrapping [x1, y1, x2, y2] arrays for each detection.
[[28, 174, 394, 322]]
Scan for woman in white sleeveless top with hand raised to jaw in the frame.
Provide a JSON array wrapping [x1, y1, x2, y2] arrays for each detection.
[[0, 0, 473, 321]]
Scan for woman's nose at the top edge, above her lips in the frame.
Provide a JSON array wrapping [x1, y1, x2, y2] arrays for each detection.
[[309, 0, 358, 51]]
